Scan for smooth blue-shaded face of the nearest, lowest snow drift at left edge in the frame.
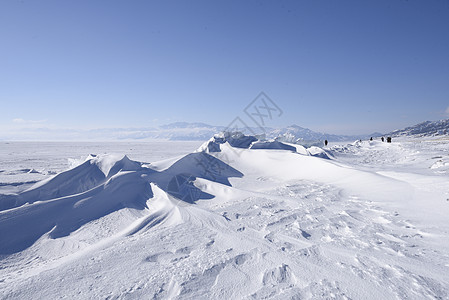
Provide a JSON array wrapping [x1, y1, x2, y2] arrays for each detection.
[[0, 172, 152, 254]]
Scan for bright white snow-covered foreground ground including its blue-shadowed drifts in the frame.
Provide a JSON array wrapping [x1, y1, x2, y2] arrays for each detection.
[[0, 135, 449, 299]]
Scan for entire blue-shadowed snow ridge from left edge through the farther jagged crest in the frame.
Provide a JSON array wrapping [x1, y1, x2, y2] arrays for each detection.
[[0, 132, 328, 254]]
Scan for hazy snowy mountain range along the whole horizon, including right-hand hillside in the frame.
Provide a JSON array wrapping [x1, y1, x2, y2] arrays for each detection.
[[0, 119, 449, 144]]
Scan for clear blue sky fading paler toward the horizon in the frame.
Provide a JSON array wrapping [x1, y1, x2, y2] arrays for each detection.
[[0, 0, 449, 134]]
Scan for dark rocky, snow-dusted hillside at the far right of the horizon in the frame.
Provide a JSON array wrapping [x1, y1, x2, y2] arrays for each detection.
[[388, 119, 449, 137]]
